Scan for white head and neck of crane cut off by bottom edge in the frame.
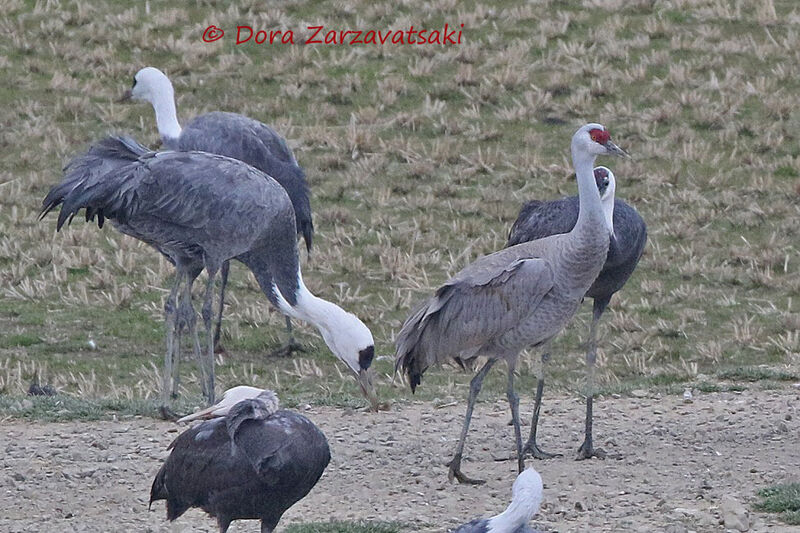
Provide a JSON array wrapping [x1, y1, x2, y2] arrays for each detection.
[[451, 468, 544, 533]]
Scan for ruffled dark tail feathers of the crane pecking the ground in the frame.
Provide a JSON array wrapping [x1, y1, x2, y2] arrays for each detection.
[[39, 136, 154, 230]]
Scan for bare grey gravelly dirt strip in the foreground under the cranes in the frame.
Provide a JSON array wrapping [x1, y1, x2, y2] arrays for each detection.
[[0, 386, 800, 533]]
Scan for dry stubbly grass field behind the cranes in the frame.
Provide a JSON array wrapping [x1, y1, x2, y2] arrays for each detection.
[[0, 0, 800, 418]]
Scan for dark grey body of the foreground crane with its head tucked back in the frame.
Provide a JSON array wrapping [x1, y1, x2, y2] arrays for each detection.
[[150, 391, 331, 533]]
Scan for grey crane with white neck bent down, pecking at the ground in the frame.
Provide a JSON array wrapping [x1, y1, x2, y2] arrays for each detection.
[[40, 137, 377, 408]]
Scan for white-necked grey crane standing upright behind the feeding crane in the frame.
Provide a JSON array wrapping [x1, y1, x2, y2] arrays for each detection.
[[121, 67, 314, 353]]
